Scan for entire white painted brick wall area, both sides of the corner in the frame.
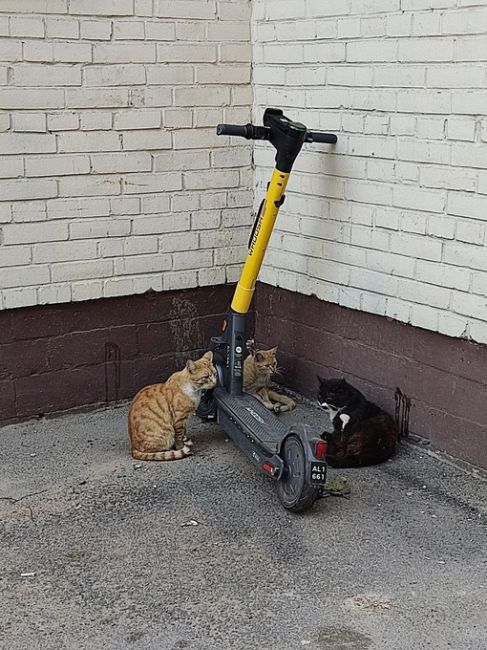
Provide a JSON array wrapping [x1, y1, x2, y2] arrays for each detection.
[[0, 0, 487, 343]]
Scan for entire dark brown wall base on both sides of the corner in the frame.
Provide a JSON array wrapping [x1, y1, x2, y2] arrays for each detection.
[[0, 284, 487, 468]]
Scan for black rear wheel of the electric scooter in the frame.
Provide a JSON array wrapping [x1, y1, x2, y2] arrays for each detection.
[[277, 435, 319, 512]]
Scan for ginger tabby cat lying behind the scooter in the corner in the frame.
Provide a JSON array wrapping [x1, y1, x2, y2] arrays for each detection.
[[243, 342, 296, 413]]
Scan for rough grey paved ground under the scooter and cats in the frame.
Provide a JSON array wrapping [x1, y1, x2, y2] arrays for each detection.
[[0, 394, 487, 650]]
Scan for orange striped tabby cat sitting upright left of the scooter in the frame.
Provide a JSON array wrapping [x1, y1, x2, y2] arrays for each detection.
[[128, 352, 216, 460]]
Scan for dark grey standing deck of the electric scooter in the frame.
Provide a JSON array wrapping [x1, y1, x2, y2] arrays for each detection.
[[214, 388, 288, 453]]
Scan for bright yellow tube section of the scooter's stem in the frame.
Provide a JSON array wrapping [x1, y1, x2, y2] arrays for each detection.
[[231, 167, 289, 314]]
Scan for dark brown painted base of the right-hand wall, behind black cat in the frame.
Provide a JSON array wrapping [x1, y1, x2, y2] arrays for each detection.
[[255, 284, 487, 468]]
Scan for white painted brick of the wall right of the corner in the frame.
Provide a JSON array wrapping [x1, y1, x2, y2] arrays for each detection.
[[252, 0, 487, 343]]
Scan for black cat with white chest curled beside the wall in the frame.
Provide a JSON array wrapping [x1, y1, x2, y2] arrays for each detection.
[[318, 377, 398, 467]]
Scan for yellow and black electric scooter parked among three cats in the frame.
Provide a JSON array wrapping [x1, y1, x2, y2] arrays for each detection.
[[196, 108, 337, 512]]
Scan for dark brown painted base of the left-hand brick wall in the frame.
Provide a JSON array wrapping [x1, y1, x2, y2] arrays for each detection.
[[0, 285, 242, 422]]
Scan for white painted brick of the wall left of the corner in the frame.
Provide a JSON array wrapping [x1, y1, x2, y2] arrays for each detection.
[[0, 0, 252, 309]]
